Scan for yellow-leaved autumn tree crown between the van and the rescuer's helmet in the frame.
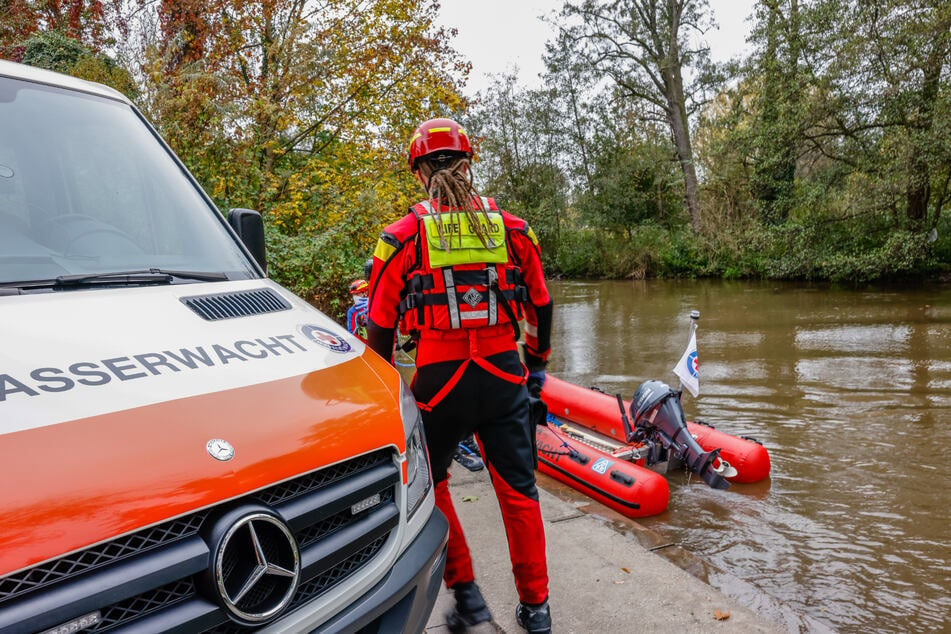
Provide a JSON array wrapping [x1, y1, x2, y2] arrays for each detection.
[[145, 0, 465, 218]]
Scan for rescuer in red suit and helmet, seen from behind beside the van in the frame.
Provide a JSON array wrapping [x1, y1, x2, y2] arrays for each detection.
[[367, 119, 552, 633]]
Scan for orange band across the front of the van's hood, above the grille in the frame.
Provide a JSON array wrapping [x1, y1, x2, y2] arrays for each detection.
[[0, 353, 405, 575]]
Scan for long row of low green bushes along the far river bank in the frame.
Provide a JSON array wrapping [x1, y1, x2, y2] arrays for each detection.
[[546, 210, 951, 282]]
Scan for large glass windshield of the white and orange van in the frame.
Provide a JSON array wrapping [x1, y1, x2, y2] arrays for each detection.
[[0, 77, 258, 284]]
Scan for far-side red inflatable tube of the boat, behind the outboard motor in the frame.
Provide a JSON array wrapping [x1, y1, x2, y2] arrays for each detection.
[[541, 374, 770, 488]]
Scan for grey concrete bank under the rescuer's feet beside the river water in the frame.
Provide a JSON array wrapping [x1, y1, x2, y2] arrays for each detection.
[[426, 465, 821, 634]]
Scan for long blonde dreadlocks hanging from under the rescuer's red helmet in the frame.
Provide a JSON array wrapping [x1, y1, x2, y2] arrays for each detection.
[[420, 154, 498, 251]]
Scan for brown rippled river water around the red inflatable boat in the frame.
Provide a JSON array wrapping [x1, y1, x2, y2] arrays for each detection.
[[549, 280, 951, 632]]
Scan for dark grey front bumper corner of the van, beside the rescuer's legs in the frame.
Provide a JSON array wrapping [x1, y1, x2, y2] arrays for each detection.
[[314, 508, 449, 634]]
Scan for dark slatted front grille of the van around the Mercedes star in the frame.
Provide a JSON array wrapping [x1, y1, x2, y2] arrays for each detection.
[[0, 449, 400, 633]]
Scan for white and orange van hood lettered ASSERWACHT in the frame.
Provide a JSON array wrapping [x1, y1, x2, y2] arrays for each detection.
[[0, 280, 405, 575]]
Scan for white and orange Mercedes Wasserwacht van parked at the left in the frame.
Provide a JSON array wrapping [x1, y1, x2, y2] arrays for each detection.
[[0, 62, 448, 634]]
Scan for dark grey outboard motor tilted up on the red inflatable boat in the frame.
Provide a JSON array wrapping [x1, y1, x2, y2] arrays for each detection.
[[631, 381, 735, 489]]
